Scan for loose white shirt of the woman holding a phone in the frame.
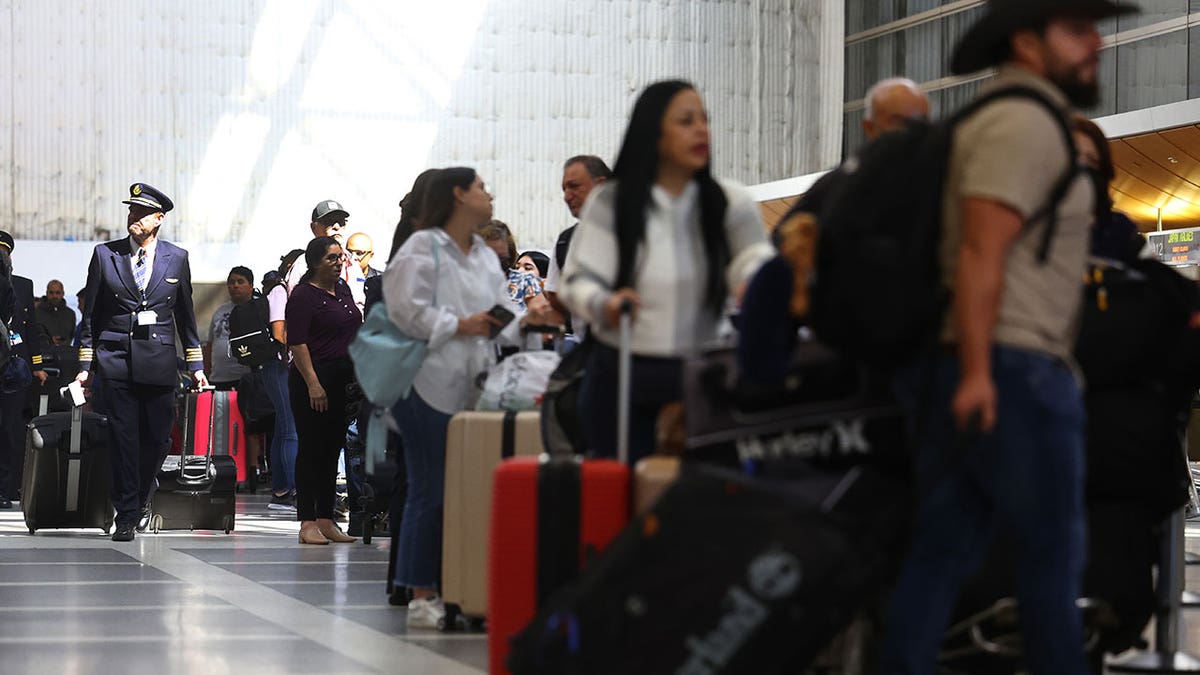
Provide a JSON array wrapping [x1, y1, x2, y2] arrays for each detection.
[[383, 227, 520, 414]]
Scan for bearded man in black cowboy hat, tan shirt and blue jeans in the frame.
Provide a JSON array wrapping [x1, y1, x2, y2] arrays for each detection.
[[880, 0, 1136, 675]]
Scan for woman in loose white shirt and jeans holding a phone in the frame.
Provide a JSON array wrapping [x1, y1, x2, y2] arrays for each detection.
[[383, 168, 517, 628]]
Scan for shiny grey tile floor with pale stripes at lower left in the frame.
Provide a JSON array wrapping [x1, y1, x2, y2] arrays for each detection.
[[0, 495, 487, 675]]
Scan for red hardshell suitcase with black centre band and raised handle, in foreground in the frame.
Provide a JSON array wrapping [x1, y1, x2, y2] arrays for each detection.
[[487, 303, 632, 675]]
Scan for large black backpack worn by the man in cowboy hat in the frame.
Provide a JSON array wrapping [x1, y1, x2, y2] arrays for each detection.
[[810, 86, 1078, 366]]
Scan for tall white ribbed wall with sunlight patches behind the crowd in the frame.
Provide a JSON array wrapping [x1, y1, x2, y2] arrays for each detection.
[[0, 0, 844, 279]]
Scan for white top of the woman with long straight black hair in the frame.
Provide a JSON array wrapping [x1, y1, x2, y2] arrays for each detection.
[[559, 180, 775, 358]]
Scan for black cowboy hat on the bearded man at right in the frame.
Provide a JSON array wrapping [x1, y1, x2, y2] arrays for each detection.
[[950, 0, 1141, 74]]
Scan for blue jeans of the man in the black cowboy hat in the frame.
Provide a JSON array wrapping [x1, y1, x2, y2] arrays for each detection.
[[880, 347, 1088, 675]]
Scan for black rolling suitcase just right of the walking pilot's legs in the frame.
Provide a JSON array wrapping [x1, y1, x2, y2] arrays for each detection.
[[150, 386, 238, 534]]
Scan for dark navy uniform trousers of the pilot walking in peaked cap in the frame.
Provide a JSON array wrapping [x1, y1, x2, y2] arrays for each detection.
[[102, 378, 175, 524]]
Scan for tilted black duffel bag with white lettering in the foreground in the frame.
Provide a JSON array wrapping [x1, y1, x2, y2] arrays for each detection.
[[508, 464, 910, 675]]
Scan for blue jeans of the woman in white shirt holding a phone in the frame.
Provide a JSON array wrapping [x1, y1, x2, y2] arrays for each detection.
[[391, 389, 450, 589]]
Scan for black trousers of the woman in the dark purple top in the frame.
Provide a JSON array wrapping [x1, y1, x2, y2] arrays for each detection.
[[288, 359, 354, 521]]
